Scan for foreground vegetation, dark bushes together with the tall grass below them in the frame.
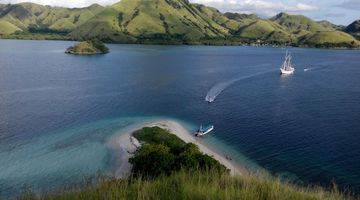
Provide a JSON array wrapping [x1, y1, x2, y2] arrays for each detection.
[[16, 127, 349, 200]]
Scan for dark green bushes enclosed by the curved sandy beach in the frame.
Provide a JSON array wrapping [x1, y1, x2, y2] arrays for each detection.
[[129, 127, 228, 178]]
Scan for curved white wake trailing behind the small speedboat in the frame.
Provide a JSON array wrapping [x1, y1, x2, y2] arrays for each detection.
[[205, 69, 278, 103]]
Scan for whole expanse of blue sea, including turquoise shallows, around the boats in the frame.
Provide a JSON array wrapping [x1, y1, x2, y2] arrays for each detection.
[[0, 40, 360, 196]]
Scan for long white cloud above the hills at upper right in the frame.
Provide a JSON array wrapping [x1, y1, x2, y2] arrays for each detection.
[[191, 0, 318, 16]]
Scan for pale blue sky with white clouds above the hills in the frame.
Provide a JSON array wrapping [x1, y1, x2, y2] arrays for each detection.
[[0, 0, 360, 25]]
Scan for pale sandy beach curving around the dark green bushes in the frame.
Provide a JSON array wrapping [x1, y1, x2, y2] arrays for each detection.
[[108, 120, 245, 178]]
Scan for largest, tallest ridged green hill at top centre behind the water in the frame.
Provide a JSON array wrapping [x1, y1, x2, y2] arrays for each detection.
[[71, 0, 229, 42]]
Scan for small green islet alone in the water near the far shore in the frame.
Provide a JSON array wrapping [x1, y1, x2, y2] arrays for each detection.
[[65, 39, 109, 55]]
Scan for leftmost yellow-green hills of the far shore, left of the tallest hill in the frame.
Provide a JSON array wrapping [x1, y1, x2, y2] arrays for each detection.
[[0, 3, 104, 34]]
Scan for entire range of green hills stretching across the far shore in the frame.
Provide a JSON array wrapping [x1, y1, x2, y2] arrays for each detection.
[[0, 0, 360, 47]]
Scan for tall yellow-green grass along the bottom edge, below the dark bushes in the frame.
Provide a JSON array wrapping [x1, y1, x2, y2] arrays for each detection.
[[35, 170, 349, 200]]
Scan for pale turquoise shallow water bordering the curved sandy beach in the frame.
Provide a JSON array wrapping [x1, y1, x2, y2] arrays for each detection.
[[0, 117, 260, 196]]
